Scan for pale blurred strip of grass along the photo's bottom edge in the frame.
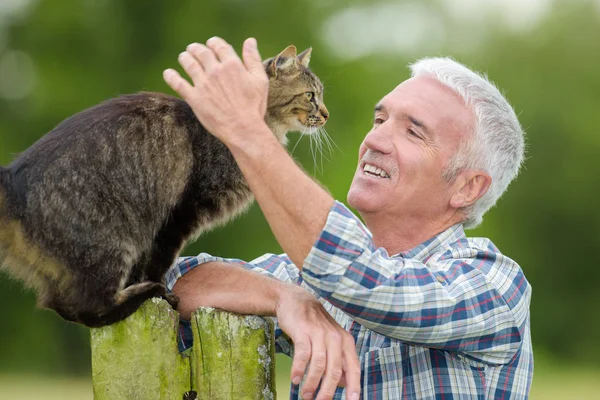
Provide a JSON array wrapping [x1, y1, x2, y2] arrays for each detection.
[[0, 355, 600, 400]]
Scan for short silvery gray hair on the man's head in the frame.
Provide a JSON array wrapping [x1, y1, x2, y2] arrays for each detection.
[[409, 58, 525, 228]]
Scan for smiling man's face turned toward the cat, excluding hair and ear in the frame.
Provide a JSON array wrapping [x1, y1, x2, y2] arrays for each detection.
[[348, 76, 474, 221]]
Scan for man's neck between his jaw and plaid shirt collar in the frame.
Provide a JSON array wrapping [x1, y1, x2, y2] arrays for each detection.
[[361, 214, 462, 255]]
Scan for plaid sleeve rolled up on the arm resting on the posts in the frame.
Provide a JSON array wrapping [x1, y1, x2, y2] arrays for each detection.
[[165, 253, 302, 357]]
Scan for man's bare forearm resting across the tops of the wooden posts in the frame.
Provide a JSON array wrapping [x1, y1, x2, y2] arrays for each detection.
[[173, 262, 288, 319]]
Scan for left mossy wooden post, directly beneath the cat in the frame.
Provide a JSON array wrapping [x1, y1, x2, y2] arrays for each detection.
[[91, 298, 190, 400]]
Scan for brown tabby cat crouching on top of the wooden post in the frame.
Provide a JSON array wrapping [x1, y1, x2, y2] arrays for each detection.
[[0, 46, 329, 327]]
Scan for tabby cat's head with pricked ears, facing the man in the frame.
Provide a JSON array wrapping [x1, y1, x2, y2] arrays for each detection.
[[263, 46, 329, 143]]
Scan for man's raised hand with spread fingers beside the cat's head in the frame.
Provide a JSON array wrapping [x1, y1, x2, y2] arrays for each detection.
[[163, 37, 272, 146]]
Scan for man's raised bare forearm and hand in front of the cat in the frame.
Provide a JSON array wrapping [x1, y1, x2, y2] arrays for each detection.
[[164, 38, 334, 268]]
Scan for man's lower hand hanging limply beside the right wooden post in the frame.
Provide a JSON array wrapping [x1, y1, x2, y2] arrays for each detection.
[[275, 287, 360, 400]]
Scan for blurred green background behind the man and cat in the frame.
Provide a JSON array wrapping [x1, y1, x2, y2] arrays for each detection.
[[0, 0, 600, 400]]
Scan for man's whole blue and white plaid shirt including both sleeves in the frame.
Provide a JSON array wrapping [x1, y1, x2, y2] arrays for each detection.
[[167, 202, 533, 400]]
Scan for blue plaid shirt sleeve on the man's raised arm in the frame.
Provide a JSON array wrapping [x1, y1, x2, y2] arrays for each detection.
[[301, 202, 531, 364]]
